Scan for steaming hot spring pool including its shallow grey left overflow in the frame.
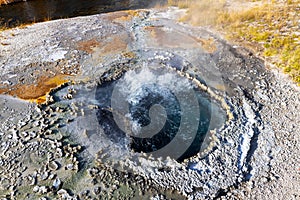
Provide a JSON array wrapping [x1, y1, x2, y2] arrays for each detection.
[[54, 66, 227, 161]]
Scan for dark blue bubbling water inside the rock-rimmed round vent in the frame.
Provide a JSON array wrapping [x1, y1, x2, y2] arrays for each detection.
[[96, 67, 225, 161]]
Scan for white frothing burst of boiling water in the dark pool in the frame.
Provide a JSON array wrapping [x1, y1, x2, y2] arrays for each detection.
[[118, 67, 193, 135]]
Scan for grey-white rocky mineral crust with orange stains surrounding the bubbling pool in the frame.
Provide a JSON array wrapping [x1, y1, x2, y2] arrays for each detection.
[[0, 8, 300, 199]]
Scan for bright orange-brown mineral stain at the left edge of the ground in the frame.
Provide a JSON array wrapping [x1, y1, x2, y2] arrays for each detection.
[[0, 74, 71, 104]]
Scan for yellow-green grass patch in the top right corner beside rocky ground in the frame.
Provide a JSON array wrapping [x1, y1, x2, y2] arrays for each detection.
[[170, 0, 300, 86]]
